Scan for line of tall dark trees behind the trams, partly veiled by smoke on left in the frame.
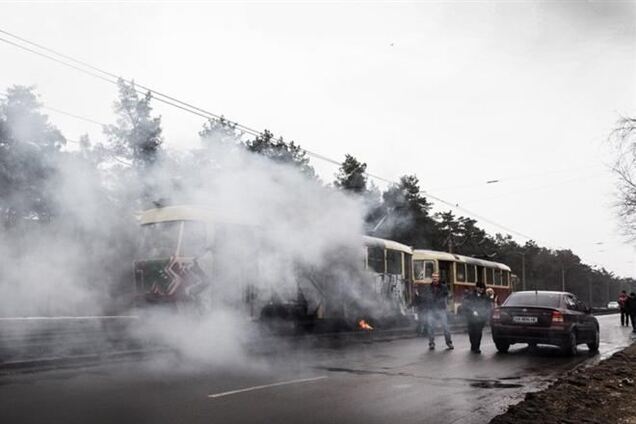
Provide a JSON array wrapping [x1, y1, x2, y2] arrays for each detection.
[[0, 80, 636, 306]]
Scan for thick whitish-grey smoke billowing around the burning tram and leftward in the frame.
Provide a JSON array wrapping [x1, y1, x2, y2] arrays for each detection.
[[0, 105, 400, 363]]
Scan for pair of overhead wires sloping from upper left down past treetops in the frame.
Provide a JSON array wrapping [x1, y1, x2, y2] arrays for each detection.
[[0, 28, 533, 240]]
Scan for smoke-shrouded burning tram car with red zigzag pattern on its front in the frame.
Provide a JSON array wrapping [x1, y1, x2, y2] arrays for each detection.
[[133, 205, 413, 324]]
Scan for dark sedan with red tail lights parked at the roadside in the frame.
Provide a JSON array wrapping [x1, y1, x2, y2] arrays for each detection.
[[491, 291, 599, 355]]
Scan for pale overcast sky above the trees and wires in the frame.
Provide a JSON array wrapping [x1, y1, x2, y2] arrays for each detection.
[[0, 1, 636, 277]]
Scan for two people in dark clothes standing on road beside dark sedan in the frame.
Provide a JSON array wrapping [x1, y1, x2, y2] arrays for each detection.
[[414, 273, 496, 353]]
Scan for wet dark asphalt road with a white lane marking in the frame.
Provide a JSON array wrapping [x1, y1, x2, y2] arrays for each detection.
[[0, 315, 631, 424]]
